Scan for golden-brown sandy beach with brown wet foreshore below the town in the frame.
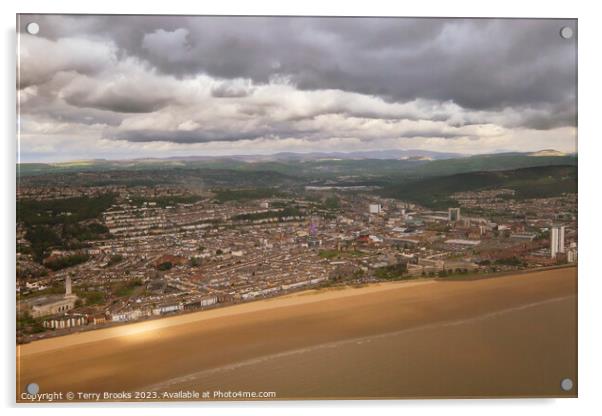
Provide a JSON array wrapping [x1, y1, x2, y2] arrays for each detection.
[[17, 268, 577, 400]]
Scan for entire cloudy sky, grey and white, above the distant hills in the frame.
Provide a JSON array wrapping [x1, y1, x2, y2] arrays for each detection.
[[17, 15, 577, 162]]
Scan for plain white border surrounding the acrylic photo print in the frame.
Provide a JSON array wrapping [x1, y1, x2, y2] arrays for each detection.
[[0, 0, 602, 416]]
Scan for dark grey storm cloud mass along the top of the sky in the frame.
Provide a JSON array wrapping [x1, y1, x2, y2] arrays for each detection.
[[21, 16, 576, 113]]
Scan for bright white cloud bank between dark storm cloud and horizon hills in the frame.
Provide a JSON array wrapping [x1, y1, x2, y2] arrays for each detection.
[[19, 29, 576, 159]]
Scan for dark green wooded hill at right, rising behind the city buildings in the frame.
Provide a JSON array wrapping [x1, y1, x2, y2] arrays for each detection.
[[381, 165, 577, 208]]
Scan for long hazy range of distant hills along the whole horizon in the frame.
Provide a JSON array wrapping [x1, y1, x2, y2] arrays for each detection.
[[17, 150, 577, 181]]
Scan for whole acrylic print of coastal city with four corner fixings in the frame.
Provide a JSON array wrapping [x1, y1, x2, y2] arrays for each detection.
[[16, 15, 578, 403]]
